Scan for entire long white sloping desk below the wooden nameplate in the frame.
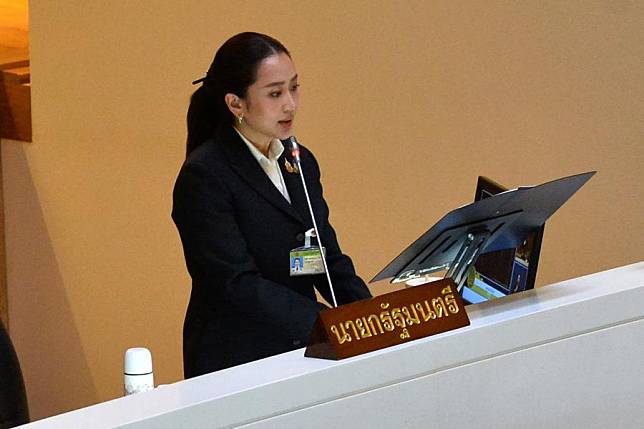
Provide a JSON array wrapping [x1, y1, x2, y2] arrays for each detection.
[[18, 262, 644, 429]]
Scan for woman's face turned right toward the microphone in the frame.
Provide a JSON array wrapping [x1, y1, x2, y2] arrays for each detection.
[[237, 53, 299, 143]]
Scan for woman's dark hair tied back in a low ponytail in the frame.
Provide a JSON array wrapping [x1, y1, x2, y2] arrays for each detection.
[[187, 32, 290, 154]]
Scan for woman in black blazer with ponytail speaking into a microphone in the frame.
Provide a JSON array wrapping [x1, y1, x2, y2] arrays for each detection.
[[172, 33, 371, 378]]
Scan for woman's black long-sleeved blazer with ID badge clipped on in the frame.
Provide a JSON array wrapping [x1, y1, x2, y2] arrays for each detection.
[[172, 126, 371, 378]]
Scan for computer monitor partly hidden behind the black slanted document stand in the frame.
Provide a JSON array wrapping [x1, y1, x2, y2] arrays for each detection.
[[463, 176, 544, 304]]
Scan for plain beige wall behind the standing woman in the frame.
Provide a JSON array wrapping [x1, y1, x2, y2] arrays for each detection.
[[2, 0, 644, 417]]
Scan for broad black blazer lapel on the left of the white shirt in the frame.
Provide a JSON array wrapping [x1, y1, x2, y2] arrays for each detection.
[[220, 127, 306, 223]]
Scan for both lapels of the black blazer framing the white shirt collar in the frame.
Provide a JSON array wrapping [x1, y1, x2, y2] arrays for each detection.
[[217, 126, 309, 223]]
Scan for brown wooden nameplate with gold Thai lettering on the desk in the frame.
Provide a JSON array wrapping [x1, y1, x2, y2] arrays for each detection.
[[304, 279, 470, 360]]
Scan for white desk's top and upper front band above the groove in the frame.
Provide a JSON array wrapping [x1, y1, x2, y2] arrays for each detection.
[[25, 262, 644, 428]]
